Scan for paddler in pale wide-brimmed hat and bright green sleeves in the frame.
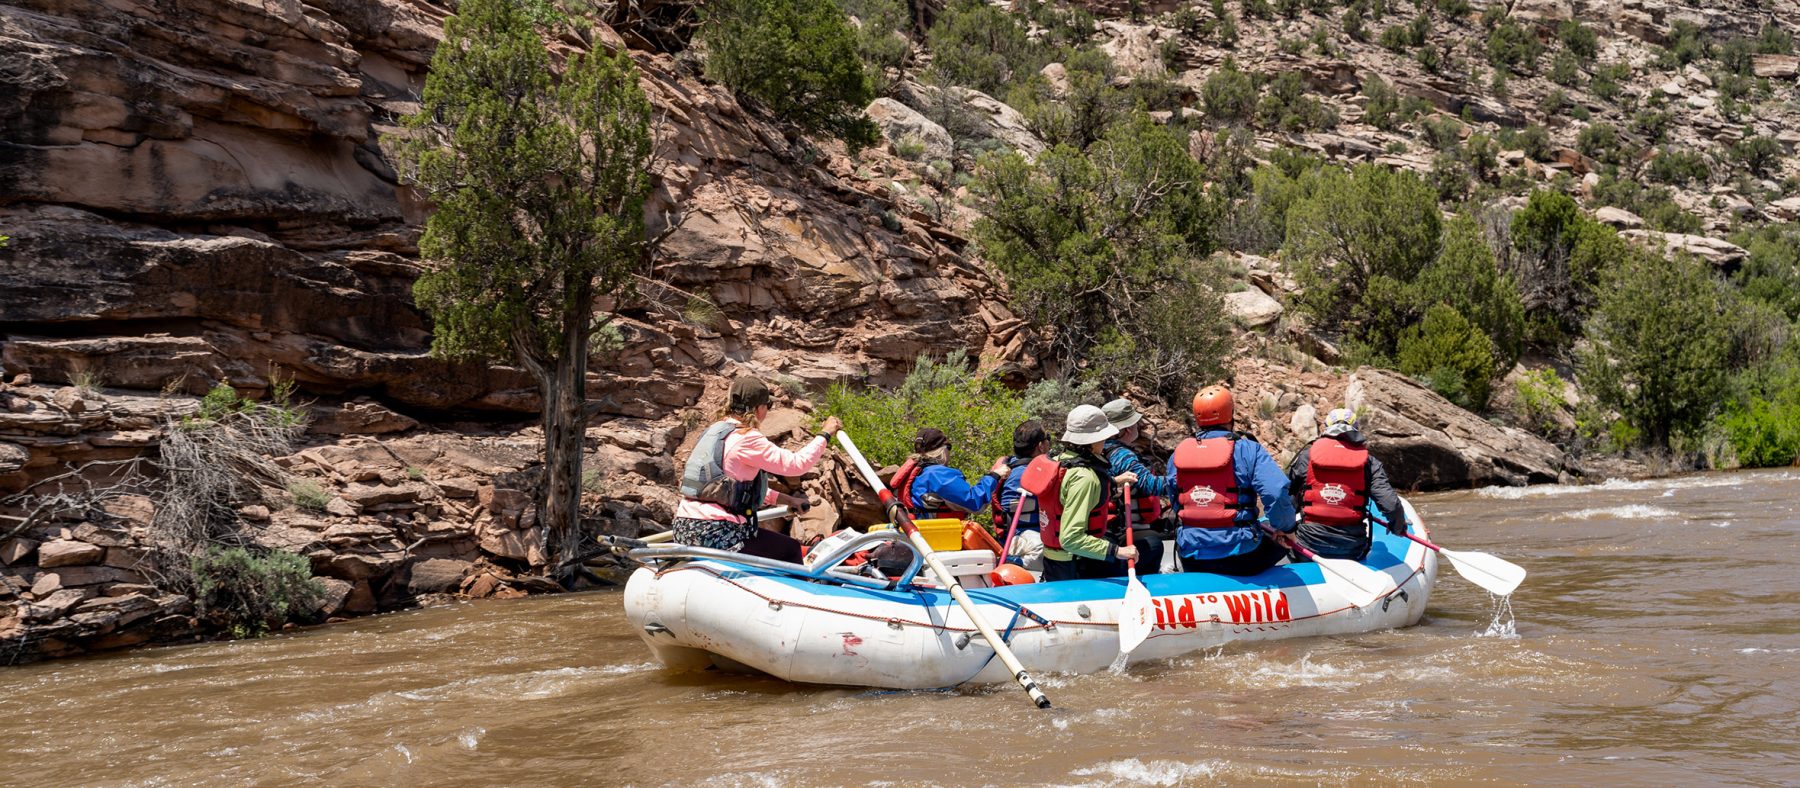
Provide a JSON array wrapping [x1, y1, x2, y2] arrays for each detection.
[[1021, 405, 1163, 583]]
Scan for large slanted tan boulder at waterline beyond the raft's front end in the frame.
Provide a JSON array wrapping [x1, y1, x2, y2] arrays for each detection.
[[1345, 367, 1570, 489]]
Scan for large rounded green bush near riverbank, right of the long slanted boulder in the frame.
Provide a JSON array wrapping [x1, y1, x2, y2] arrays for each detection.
[[1580, 254, 1733, 448]]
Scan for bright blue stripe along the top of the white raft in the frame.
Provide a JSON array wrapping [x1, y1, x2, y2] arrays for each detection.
[[704, 527, 1413, 608]]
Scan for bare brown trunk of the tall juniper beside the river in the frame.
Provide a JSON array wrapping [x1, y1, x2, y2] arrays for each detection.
[[538, 286, 594, 574]]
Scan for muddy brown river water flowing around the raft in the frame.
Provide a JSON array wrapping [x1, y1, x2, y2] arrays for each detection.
[[0, 470, 1800, 784]]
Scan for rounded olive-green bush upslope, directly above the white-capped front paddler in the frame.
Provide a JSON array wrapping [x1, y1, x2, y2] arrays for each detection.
[[1283, 164, 1440, 329]]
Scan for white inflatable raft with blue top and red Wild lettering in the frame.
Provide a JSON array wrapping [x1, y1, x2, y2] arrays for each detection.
[[625, 504, 1438, 689]]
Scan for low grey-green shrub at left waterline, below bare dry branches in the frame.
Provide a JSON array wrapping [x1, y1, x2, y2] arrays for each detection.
[[191, 547, 324, 637]]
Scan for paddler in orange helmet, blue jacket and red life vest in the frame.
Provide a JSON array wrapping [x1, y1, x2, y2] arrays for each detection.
[[1170, 385, 1294, 576]]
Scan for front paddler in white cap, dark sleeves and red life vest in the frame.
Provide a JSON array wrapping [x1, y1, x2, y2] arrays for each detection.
[[1287, 408, 1406, 561]]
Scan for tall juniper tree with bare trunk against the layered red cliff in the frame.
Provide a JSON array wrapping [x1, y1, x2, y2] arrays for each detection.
[[392, 0, 652, 568]]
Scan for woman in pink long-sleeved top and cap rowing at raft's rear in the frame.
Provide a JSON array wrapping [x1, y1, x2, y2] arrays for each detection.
[[671, 378, 842, 563]]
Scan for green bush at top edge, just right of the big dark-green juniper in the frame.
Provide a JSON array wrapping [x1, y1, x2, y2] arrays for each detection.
[[927, 0, 1051, 95]]
